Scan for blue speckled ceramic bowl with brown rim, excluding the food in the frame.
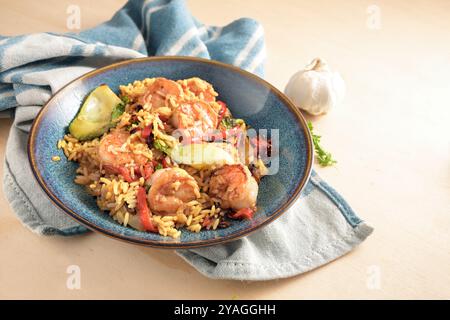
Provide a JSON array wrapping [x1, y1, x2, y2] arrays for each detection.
[[28, 57, 313, 248]]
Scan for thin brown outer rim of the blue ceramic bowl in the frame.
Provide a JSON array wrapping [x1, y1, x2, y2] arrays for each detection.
[[27, 56, 314, 249]]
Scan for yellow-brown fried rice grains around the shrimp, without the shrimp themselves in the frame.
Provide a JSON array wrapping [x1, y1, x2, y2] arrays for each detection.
[[57, 78, 266, 238]]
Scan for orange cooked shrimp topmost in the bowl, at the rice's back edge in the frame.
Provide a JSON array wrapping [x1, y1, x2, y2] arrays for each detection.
[[139, 78, 183, 110]]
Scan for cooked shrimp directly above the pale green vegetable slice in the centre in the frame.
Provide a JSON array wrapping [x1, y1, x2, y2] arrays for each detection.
[[171, 101, 219, 135]]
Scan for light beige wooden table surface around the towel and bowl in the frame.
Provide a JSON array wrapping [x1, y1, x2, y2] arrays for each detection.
[[0, 0, 450, 299]]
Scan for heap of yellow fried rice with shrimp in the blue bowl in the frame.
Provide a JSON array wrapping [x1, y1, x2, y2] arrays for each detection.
[[58, 78, 265, 238]]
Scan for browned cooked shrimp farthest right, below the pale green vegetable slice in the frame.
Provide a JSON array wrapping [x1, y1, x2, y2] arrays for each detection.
[[209, 164, 258, 210]]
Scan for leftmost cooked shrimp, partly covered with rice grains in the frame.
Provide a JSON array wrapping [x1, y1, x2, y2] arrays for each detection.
[[98, 129, 148, 167]]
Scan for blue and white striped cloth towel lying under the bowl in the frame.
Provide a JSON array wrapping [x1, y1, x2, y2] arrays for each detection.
[[0, 0, 372, 280]]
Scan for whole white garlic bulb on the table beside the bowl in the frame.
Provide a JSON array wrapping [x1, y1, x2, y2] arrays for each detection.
[[284, 58, 345, 115]]
